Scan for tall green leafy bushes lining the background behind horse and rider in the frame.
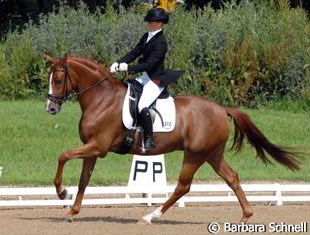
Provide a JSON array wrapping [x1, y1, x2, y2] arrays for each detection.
[[0, 0, 310, 106]]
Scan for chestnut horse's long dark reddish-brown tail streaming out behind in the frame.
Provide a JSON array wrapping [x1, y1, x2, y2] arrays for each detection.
[[226, 109, 300, 171]]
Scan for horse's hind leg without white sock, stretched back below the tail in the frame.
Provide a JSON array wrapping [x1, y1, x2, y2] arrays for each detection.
[[208, 155, 253, 222]]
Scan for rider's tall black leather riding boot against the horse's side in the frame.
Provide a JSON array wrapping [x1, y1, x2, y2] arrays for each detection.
[[139, 108, 155, 150]]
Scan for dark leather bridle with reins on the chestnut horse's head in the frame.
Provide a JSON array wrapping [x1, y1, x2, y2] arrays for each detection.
[[47, 65, 109, 105]]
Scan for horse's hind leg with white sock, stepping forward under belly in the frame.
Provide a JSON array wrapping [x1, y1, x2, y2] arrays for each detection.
[[139, 154, 204, 224]]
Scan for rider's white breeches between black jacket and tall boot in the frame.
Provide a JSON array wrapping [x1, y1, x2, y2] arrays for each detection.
[[136, 72, 164, 113]]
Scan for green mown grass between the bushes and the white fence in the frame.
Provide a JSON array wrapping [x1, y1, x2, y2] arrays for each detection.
[[0, 100, 310, 186]]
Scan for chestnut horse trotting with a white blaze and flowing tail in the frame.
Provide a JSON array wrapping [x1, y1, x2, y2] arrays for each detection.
[[44, 54, 300, 223]]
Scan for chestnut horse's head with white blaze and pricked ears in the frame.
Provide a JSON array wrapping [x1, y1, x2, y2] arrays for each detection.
[[44, 54, 73, 114]]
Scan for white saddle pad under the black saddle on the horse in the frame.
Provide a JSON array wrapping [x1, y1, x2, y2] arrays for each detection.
[[122, 84, 176, 132]]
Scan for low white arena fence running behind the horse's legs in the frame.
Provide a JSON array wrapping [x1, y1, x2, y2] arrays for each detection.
[[0, 183, 310, 207]]
